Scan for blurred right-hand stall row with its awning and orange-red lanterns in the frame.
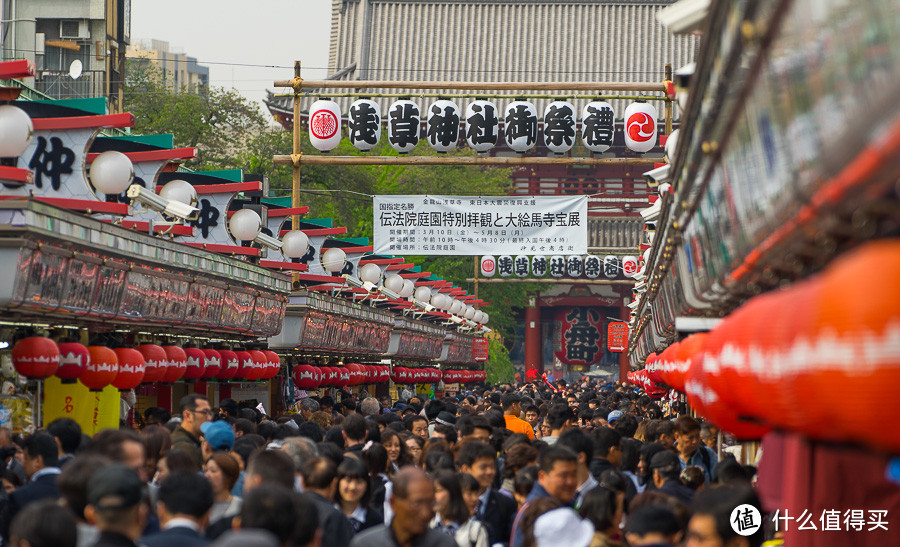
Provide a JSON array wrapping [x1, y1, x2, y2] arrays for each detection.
[[628, 0, 900, 546]]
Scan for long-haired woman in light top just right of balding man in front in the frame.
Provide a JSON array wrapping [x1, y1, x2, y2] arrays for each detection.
[[429, 471, 488, 547]]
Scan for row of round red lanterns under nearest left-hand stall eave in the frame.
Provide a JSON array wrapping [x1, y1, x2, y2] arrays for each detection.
[[12, 336, 281, 390]]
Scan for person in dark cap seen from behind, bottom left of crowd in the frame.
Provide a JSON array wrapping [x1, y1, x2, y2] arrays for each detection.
[[84, 464, 148, 547]]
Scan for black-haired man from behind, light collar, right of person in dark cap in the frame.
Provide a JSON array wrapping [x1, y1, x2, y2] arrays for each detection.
[[141, 471, 213, 547]]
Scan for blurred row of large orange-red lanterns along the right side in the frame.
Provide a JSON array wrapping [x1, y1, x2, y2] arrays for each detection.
[[632, 240, 900, 452]]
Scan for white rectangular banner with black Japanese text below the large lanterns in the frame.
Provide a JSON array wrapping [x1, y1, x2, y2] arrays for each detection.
[[373, 196, 587, 255]]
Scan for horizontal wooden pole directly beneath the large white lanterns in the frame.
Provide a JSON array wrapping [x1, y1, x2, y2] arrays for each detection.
[[273, 153, 660, 167]]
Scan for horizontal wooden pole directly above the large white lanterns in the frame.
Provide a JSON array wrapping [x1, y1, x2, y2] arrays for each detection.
[[275, 79, 666, 93]]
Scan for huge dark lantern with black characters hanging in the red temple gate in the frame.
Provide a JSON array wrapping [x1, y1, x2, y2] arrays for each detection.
[[554, 306, 604, 367]]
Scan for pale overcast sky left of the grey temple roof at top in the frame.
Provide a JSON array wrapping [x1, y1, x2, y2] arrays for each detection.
[[131, 0, 331, 117]]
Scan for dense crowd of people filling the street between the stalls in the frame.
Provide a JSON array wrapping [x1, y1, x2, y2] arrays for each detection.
[[0, 381, 764, 547]]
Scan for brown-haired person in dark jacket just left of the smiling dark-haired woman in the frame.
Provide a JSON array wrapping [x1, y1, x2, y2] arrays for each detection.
[[300, 456, 350, 547]]
